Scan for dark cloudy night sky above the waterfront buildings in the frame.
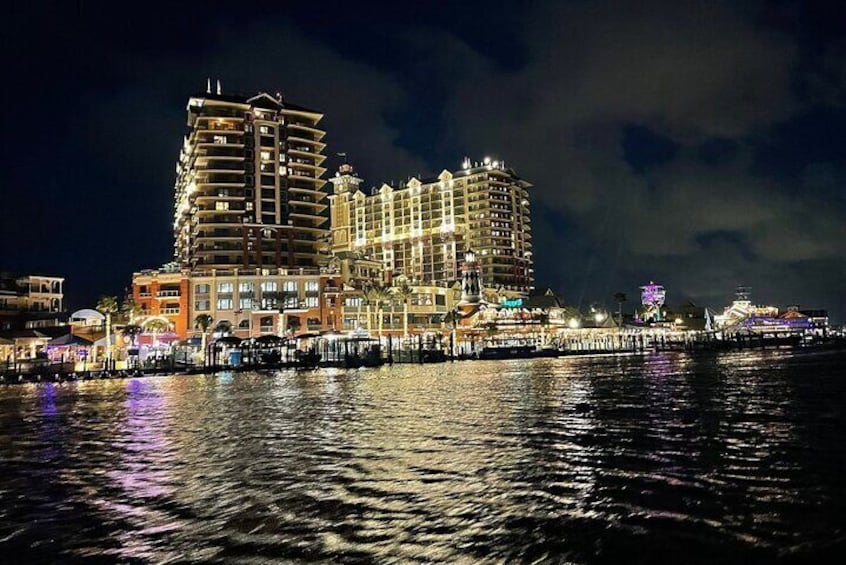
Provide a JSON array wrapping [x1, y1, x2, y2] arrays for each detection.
[[0, 0, 846, 321]]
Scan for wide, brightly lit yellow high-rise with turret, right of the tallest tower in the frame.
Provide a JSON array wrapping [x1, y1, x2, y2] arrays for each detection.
[[329, 159, 534, 293]]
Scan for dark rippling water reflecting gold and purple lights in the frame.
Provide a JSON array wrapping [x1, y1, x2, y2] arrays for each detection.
[[0, 352, 846, 564]]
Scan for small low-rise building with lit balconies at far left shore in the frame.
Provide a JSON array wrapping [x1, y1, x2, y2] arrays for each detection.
[[0, 272, 67, 330]]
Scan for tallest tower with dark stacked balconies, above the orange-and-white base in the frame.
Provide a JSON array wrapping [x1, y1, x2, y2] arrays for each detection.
[[173, 84, 328, 270]]
